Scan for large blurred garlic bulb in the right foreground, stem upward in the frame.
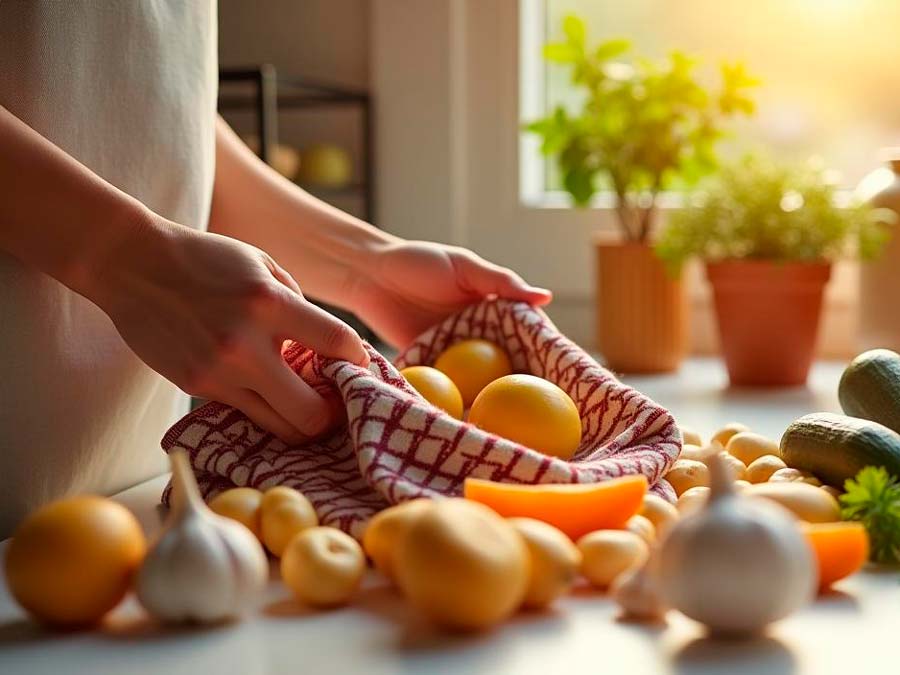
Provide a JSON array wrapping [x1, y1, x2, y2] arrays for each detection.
[[660, 454, 817, 636]]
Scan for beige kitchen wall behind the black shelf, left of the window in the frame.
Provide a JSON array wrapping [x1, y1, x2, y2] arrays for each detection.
[[219, 0, 855, 354]]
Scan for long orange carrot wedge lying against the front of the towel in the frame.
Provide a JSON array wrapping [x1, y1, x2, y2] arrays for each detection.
[[463, 476, 647, 540]]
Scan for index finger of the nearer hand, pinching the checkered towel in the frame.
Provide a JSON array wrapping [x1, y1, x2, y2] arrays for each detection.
[[275, 294, 369, 366]]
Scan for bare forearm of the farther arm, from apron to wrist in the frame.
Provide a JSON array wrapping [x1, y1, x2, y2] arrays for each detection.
[[209, 119, 396, 307]]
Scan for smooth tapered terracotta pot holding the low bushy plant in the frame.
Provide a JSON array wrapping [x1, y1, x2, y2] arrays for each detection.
[[706, 260, 831, 386]]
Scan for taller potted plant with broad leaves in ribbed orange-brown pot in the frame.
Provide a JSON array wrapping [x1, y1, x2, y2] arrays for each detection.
[[526, 16, 756, 372]]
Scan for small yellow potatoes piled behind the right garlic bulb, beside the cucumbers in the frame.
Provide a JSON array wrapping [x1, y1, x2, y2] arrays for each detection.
[[666, 422, 840, 523]]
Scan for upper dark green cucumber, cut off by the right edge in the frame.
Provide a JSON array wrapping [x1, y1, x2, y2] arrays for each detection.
[[838, 349, 900, 432]]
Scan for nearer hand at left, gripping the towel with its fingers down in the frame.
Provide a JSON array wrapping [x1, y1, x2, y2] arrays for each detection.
[[88, 218, 369, 442]]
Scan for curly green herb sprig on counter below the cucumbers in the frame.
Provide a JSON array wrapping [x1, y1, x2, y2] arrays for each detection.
[[841, 466, 900, 564]]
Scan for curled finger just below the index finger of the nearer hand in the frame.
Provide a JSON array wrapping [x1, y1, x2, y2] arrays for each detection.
[[248, 353, 338, 437]]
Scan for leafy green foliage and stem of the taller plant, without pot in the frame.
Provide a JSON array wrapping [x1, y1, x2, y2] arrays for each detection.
[[526, 16, 757, 241]]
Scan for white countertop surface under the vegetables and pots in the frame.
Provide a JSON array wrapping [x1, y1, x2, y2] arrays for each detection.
[[0, 360, 900, 675]]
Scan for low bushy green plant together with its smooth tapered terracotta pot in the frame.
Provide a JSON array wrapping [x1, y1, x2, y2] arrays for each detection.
[[656, 156, 888, 385]]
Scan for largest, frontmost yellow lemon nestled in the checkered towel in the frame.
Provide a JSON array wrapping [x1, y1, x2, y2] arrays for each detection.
[[469, 375, 581, 459]]
